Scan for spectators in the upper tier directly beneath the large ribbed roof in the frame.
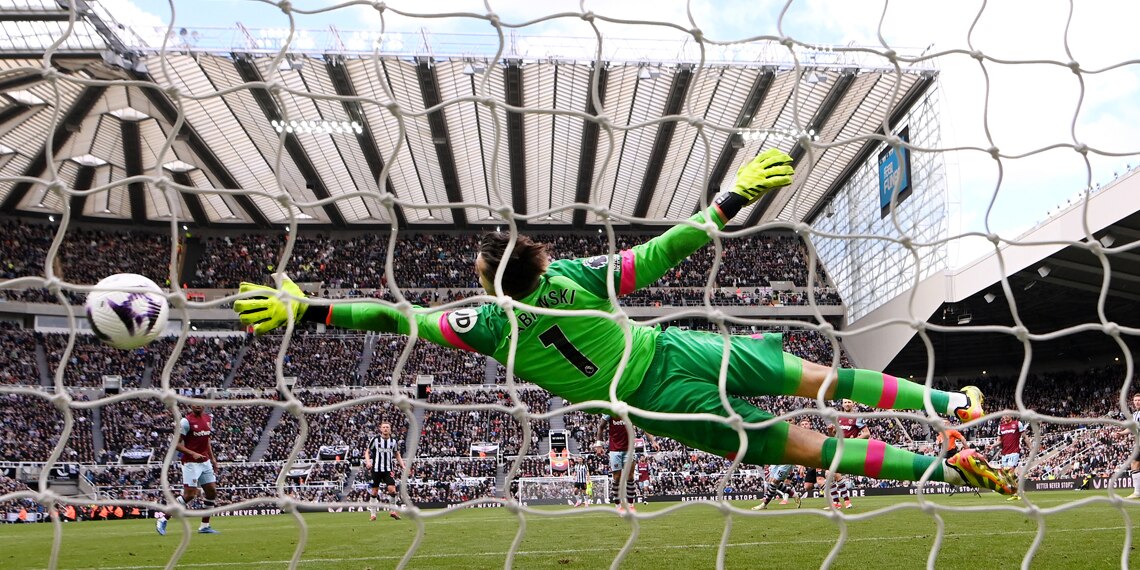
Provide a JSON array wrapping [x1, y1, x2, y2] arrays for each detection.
[[0, 220, 839, 316]]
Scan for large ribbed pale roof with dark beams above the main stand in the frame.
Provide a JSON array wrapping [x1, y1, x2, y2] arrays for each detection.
[[0, 1, 936, 229]]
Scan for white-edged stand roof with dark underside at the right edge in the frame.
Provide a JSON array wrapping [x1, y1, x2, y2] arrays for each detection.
[[845, 169, 1140, 376]]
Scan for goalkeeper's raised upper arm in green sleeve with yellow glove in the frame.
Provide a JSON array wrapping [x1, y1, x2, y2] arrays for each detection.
[[562, 148, 793, 295]]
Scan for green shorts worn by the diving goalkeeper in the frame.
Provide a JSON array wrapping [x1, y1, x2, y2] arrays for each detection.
[[627, 328, 801, 465]]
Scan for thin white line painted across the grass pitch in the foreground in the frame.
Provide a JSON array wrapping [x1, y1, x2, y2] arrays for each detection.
[[57, 526, 1127, 570]]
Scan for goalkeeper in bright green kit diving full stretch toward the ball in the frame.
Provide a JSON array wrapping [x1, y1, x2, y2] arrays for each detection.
[[234, 149, 1017, 495]]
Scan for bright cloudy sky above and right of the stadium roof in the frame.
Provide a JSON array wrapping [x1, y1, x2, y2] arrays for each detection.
[[101, 0, 1140, 267]]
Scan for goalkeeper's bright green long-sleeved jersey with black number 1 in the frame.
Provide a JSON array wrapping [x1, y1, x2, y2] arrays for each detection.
[[328, 206, 724, 402]]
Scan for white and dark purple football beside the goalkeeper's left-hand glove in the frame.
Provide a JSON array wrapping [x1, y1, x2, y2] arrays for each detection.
[[84, 274, 170, 349]]
